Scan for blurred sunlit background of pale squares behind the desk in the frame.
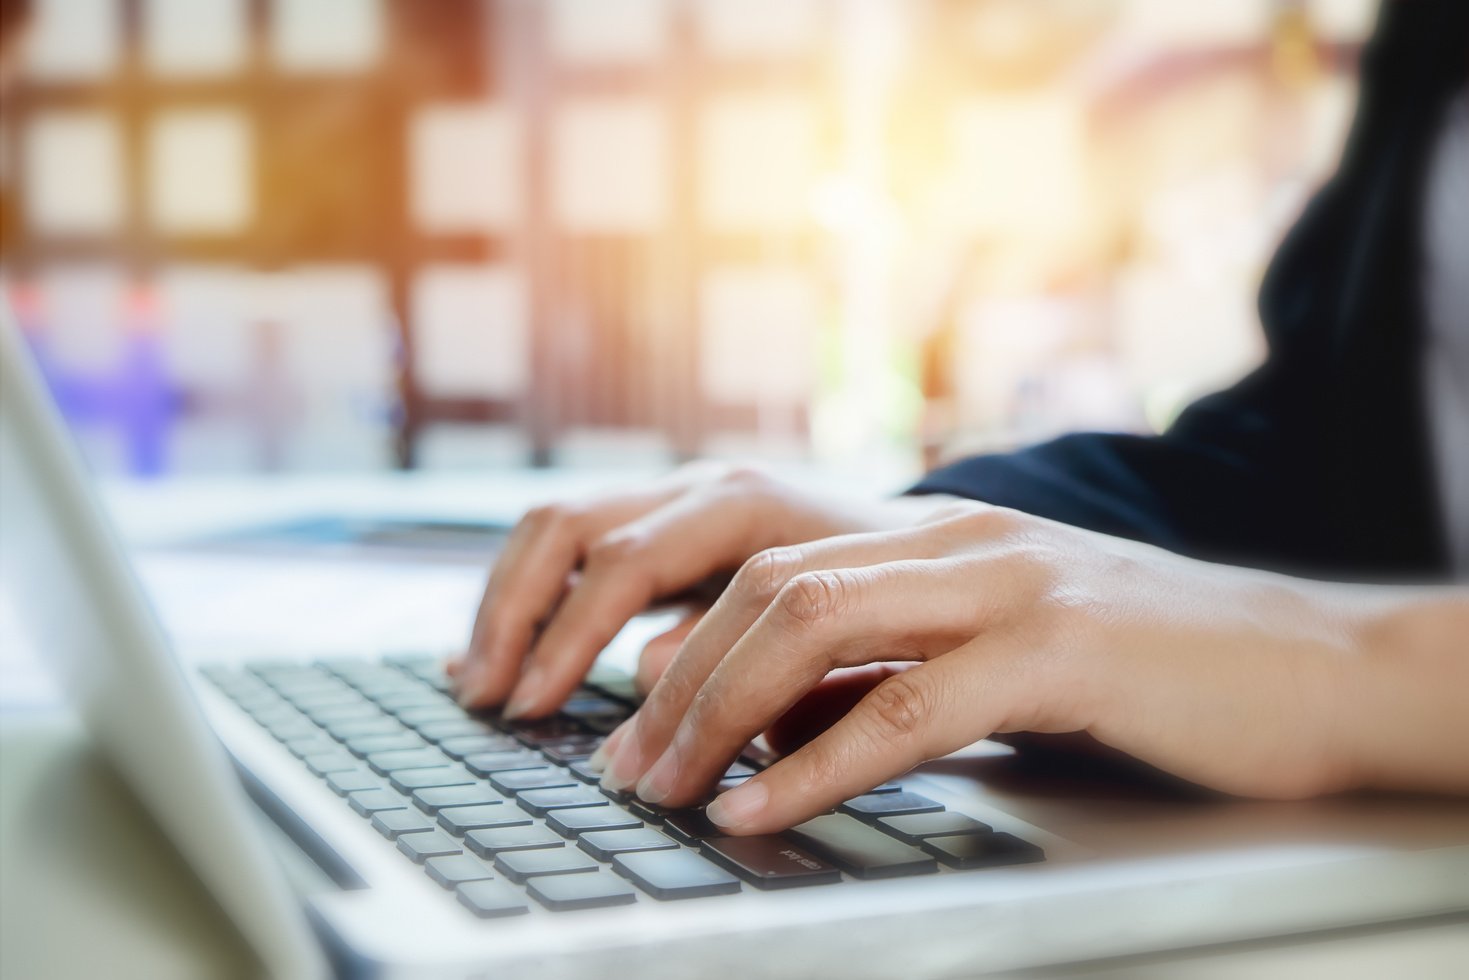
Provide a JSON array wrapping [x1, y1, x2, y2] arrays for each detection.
[[0, 0, 1376, 476]]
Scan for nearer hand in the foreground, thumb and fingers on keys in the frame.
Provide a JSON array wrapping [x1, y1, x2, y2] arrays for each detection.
[[601, 504, 1445, 833]]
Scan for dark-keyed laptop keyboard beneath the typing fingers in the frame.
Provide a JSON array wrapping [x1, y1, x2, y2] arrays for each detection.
[[204, 655, 1044, 918]]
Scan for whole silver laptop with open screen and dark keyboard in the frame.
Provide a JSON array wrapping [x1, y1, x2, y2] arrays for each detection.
[[0, 308, 1469, 977]]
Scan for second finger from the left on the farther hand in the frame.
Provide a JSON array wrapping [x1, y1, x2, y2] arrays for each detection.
[[505, 485, 767, 717]]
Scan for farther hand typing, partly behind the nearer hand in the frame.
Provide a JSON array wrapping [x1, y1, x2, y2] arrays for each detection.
[[454, 464, 952, 717]]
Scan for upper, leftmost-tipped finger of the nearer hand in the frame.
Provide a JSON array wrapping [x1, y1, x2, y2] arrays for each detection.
[[602, 527, 948, 789]]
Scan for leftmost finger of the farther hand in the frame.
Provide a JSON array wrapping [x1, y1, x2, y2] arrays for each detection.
[[458, 488, 676, 705]]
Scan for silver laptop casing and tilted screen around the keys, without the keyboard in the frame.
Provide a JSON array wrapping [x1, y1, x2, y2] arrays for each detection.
[[0, 308, 1469, 979]]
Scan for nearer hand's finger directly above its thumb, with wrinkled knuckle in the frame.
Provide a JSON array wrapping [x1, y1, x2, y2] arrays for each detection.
[[638, 558, 1005, 807]]
